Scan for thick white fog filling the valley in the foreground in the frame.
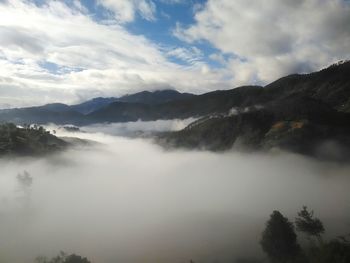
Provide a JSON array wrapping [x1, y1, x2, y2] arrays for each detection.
[[0, 121, 350, 263]]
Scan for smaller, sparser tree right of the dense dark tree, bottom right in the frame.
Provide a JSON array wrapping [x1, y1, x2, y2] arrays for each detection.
[[295, 206, 324, 241]]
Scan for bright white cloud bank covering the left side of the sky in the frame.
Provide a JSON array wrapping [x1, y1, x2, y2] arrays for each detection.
[[0, 0, 228, 106]]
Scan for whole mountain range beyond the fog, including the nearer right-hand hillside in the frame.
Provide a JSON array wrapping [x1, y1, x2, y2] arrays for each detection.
[[0, 62, 350, 160]]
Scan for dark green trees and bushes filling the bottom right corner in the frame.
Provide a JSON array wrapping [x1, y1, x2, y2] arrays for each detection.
[[261, 206, 350, 263]]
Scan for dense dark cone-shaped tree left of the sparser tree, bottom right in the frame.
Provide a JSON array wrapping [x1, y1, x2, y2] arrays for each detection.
[[260, 211, 300, 263]]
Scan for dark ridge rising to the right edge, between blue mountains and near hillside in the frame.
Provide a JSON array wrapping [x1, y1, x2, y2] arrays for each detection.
[[88, 62, 350, 122]]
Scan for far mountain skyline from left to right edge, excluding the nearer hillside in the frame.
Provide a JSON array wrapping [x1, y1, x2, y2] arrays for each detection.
[[0, 62, 350, 129]]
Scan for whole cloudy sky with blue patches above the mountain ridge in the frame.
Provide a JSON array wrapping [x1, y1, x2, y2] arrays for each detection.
[[0, 0, 350, 108]]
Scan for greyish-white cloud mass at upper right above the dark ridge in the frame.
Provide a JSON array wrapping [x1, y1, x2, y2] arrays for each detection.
[[174, 0, 350, 84]]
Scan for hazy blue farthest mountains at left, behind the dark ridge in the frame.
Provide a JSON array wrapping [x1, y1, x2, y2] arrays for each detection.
[[0, 90, 195, 122]]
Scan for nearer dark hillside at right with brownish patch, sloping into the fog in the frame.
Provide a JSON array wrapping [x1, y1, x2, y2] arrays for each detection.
[[157, 95, 350, 160]]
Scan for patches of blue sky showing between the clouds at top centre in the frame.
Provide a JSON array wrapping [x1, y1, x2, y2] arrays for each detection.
[[72, 0, 222, 67]]
